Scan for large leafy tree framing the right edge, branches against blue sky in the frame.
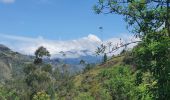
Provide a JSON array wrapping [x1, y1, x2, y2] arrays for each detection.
[[94, 0, 170, 100]]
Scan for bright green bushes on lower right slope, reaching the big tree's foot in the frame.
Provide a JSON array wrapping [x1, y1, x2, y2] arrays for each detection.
[[99, 66, 151, 100]]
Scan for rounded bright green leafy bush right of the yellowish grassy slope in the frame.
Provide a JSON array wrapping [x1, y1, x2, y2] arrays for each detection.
[[100, 67, 135, 100]]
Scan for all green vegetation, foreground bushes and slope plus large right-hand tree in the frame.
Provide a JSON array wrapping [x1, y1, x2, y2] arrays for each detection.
[[0, 0, 170, 100]]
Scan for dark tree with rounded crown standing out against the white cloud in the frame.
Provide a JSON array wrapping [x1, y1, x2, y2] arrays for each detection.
[[34, 46, 50, 64]]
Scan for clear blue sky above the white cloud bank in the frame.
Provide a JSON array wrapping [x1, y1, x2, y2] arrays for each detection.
[[0, 0, 128, 40]]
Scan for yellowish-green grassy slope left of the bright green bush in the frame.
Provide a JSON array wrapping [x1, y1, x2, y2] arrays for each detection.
[[74, 56, 130, 100]]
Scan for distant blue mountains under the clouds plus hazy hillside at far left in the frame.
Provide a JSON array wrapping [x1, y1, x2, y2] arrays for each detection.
[[0, 44, 101, 80]]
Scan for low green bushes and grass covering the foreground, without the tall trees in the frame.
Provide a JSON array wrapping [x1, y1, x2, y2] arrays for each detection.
[[0, 52, 155, 100]]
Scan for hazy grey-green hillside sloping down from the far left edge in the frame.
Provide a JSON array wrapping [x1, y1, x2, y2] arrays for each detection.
[[0, 44, 32, 82]]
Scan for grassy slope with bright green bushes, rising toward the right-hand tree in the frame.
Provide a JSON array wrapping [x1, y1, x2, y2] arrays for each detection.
[[59, 56, 152, 100]]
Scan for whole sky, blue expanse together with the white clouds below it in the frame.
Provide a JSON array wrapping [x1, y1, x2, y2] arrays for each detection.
[[0, 0, 133, 55]]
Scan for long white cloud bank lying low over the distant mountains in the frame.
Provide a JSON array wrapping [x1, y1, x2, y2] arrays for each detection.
[[0, 34, 138, 56]]
